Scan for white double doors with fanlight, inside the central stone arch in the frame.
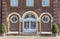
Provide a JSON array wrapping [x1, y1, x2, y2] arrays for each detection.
[[23, 15, 37, 33]]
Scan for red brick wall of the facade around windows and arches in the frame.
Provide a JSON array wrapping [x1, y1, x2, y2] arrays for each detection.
[[2, 0, 59, 32]]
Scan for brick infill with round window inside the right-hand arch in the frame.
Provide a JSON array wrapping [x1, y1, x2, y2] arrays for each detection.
[[41, 15, 51, 32]]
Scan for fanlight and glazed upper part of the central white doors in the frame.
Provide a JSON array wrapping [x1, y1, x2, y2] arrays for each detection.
[[24, 15, 36, 29]]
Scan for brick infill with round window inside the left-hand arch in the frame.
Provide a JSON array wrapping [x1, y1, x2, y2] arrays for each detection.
[[9, 15, 19, 32]]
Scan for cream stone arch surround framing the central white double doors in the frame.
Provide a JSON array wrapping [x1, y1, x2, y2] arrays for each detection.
[[22, 11, 39, 34]]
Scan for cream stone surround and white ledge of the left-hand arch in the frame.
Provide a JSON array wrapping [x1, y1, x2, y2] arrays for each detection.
[[7, 12, 21, 34]]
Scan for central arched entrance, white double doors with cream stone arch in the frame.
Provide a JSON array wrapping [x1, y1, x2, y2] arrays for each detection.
[[22, 11, 38, 33]]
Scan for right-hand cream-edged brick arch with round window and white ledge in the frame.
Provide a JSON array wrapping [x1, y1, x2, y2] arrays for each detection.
[[40, 12, 53, 34]]
